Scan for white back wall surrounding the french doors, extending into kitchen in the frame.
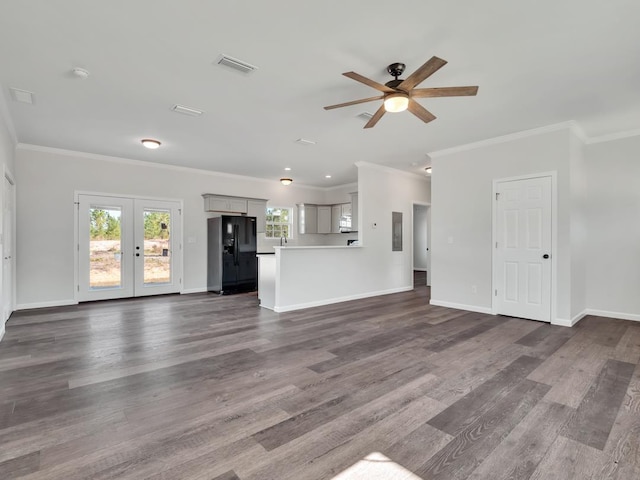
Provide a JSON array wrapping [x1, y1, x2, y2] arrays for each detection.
[[16, 146, 355, 308]]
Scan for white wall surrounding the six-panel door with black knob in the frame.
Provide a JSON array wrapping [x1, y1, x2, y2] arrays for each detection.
[[430, 128, 571, 320]]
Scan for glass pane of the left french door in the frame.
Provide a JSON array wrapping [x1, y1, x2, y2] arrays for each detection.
[[89, 207, 122, 289]]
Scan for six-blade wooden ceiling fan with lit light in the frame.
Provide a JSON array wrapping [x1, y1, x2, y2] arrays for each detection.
[[324, 57, 478, 128]]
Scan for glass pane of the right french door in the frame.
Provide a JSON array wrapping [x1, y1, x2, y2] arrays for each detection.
[[144, 209, 171, 285]]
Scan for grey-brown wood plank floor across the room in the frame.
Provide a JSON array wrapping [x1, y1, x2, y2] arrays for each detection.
[[0, 286, 640, 480]]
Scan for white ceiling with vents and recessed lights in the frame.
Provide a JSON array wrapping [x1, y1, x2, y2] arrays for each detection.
[[0, 0, 640, 186]]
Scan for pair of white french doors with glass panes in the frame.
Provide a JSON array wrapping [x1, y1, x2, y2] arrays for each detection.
[[78, 194, 182, 301]]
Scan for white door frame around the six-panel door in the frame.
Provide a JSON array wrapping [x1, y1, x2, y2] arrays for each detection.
[[491, 170, 558, 324]]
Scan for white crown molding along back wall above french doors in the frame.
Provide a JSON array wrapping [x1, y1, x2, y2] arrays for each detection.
[[16, 143, 338, 191]]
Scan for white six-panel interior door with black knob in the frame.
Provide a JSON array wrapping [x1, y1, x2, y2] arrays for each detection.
[[493, 177, 552, 322]]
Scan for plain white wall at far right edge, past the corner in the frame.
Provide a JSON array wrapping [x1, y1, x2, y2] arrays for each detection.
[[585, 136, 640, 320]]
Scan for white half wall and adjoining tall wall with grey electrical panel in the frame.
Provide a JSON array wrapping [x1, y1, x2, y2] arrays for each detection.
[[275, 162, 430, 311]]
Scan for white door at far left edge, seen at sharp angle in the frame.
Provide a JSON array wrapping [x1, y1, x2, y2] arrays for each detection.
[[2, 177, 15, 321]]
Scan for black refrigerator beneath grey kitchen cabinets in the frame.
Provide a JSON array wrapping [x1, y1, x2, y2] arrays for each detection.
[[207, 215, 258, 294]]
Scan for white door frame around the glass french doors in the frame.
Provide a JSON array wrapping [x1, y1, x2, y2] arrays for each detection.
[[75, 190, 184, 304]]
